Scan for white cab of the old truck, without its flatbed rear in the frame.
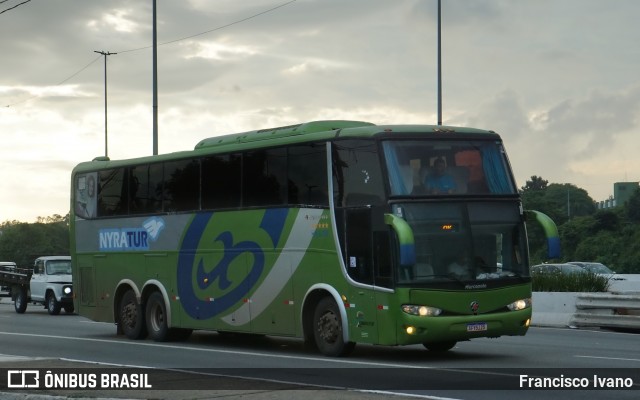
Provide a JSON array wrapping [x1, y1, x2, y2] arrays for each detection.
[[28, 256, 74, 315]]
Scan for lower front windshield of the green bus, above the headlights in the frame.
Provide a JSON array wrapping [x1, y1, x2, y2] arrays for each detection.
[[393, 202, 529, 285]]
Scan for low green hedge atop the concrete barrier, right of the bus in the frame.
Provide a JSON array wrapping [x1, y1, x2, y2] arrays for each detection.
[[531, 272, 609, 292]]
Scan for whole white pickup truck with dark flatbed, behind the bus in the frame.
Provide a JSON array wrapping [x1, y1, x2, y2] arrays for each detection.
[[0, 256, 74, 315]]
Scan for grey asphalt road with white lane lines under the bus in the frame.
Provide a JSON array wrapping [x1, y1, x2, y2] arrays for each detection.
[[0, 299, 640, 400]]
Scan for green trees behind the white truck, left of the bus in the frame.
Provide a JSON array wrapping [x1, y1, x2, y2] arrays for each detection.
[[0, 215, 69, 267]]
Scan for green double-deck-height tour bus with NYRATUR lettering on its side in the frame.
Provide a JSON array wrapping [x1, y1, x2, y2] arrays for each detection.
[[70, 121, 557, 356]]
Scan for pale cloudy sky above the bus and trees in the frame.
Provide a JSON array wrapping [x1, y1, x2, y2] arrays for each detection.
[[0, 0, 640, 223]]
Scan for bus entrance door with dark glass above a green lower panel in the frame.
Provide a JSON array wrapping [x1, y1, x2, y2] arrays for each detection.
[[342, 206, 378, 343]]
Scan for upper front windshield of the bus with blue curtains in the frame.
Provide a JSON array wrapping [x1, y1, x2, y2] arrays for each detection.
[[383, 140, 517, 196]]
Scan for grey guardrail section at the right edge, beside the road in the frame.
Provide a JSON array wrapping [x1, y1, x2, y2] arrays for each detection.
[[571, 292, 640, 329]]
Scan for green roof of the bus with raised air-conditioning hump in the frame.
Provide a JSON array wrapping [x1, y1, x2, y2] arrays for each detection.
[[74, 120, 500, 171]]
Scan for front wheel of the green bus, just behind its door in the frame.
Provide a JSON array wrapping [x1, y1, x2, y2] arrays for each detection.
[[313, 296, 355, 357]]
